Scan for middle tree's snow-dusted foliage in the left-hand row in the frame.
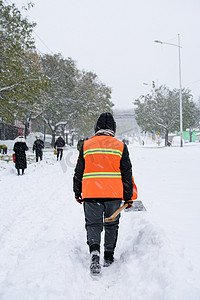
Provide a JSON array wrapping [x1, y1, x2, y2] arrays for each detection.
[[41, 54, 76, 131]]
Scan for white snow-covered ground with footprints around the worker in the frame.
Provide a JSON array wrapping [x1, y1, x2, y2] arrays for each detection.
[[0, 143, 200, 300]]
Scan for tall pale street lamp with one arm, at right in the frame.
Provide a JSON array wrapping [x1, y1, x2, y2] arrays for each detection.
[[154, 34, 183, 147]]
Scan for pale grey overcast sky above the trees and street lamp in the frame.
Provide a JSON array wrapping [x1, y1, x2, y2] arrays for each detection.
[[10, 0, 200, 109]]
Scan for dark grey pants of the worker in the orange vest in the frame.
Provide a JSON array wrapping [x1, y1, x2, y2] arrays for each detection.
[[84, 200, 121, 252]]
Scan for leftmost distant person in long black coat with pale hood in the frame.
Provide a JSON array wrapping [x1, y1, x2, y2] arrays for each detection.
[[13, 135, 28, 175]]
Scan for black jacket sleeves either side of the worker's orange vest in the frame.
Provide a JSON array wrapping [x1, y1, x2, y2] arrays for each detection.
[[73, 139, 133, 200]]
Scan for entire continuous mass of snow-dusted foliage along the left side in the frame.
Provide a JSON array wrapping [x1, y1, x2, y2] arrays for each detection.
[[0, 0, 113, 140]]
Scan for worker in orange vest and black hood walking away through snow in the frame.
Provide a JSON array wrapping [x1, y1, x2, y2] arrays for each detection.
[[73, 112, 137, 274]]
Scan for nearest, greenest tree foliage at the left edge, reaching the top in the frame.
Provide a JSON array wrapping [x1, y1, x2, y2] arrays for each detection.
[[0, 1, 46, 121]]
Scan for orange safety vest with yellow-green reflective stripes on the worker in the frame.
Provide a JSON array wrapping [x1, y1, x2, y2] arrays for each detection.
[[82, 135, 137, 199]]
